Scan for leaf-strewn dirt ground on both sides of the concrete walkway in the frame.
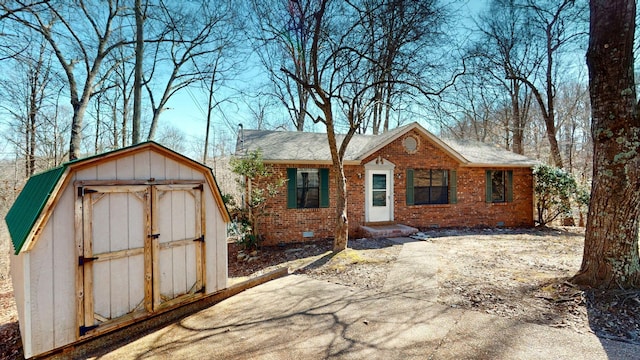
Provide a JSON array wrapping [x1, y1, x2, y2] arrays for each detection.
[[0, 228, 640, 359]]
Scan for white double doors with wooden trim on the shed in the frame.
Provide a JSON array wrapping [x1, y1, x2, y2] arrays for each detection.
[[78, 184, 204, 336]]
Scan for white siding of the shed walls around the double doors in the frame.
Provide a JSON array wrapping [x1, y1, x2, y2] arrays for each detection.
[[11, 150, 227, 357]]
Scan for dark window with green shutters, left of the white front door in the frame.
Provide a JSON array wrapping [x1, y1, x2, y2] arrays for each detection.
[[287, 168, 329, 209]]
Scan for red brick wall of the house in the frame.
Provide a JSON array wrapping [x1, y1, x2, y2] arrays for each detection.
[[255, 128, 533, 245]]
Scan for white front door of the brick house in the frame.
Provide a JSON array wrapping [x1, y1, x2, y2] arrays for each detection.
[[365, 170, 393, 222]]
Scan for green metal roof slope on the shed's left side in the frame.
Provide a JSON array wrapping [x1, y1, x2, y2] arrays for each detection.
[[5, 164, 67, 255]]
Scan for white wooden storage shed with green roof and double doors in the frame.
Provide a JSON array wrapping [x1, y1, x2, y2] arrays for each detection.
[[6, 142, 229, 357]]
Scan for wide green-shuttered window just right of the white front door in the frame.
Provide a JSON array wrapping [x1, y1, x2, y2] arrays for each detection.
[[407, 169, 457, 205]]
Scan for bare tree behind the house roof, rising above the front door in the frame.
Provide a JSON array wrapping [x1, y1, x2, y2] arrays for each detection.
[[359, 0, 447, 134]]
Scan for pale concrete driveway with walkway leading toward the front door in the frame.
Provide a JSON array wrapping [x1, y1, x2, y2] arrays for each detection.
[[76, 239, 640, 360]]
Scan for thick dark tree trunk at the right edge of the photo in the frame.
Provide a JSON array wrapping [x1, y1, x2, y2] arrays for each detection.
[[573, 0, 640, 288]]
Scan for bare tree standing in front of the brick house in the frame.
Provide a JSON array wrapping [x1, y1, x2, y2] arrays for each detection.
[[282, 0, 458, 252]]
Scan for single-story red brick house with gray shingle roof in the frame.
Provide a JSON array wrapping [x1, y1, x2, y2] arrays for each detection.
[[236, 123, 535, 245]]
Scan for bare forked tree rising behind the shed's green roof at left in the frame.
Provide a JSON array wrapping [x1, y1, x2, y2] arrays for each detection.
[[0, 0, 130, 159]]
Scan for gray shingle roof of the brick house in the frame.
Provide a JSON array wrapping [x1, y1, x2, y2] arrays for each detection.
[[236, 123, 536, 167]]
